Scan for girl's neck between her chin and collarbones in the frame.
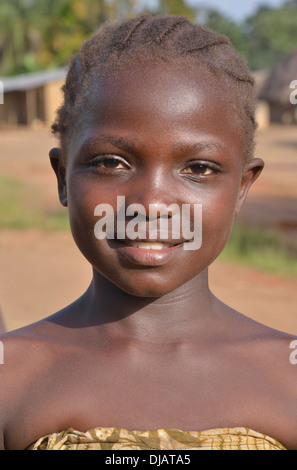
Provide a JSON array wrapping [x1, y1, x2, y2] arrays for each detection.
[[78, 271, 215, 342]]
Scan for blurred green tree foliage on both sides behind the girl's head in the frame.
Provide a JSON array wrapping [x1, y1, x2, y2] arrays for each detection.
[[0, 0, 297, 75]]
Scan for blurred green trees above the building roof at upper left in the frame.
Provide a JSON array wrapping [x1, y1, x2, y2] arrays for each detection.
[[0, 0, 146, 75]]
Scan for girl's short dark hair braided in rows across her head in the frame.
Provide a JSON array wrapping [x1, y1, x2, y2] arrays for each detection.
[[52, 14, 257, 162]]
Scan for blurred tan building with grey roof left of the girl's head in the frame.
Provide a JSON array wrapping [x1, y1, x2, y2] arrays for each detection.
[[0, 68, 66, 126]]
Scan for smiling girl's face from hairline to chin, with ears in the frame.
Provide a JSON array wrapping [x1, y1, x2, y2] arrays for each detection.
[[53, 64, 261, 297]]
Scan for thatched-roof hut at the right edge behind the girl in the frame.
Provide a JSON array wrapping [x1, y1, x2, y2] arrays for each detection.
[[259, 48, 297, 124]]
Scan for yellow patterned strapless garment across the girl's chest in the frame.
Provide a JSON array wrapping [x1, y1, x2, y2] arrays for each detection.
[[28, 427, 286, 450]]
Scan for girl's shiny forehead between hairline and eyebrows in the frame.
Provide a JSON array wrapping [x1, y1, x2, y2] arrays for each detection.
[[69, 61, 242, 157]]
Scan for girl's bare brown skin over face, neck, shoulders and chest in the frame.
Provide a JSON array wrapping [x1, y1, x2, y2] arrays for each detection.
[[0, 60, 297, 449]]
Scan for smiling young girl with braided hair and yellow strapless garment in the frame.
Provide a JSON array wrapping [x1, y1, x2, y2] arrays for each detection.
[[0, 15, 297, 450]]
